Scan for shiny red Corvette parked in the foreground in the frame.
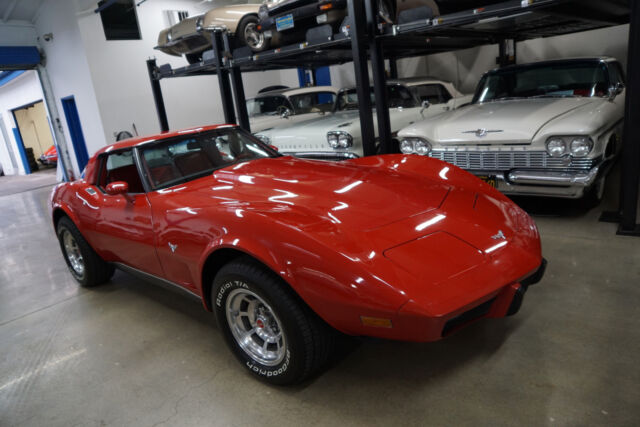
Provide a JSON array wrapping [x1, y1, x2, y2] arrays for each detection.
[[51, 125, 545, 384]]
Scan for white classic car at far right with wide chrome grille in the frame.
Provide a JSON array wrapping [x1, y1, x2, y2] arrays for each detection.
[[398, 57, 625, 200]]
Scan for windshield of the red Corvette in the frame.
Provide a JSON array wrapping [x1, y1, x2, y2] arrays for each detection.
[[141, 128, 278, 190]]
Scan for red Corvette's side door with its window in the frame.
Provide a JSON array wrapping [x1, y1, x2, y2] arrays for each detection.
[[94, 149, 163, 276]]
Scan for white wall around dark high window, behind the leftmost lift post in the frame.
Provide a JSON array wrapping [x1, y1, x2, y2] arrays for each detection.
[[78, 0, 298, 143]]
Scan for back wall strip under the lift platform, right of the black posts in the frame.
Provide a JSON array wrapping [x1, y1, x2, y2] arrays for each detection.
[[398, 25, 629, 93]]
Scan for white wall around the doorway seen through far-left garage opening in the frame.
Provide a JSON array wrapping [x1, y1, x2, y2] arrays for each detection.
[[0, 71, 44, 175]]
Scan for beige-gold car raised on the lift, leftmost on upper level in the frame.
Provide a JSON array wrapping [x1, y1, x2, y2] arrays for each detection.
[[155, 0, 269, 64]]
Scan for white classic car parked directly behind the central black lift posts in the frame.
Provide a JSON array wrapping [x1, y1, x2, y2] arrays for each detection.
[[252, 78, 471, 160]]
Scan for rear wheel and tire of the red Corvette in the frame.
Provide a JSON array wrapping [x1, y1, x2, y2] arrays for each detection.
[[56, 217, 114, 287]]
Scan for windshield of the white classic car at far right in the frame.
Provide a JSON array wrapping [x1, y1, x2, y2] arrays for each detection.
[[473, 61, 609, 103]]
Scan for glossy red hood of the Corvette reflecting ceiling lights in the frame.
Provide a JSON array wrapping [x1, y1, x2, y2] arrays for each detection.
[[183, 156, 449, 231]]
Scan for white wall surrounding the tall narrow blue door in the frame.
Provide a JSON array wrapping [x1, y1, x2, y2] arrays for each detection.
[[35, 0, 106, 176]]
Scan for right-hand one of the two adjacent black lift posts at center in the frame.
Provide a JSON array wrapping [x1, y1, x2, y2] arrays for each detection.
[[368, 0, 391, 155]]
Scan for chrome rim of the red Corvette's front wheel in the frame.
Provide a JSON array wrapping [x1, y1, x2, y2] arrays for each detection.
[[225, 289, 287, 366]]
